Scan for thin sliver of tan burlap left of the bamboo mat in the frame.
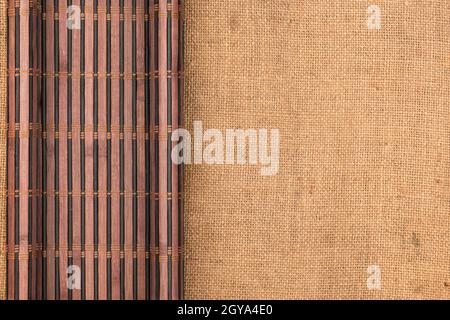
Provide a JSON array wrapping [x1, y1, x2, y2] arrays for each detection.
[[0, 0, 8, 300]]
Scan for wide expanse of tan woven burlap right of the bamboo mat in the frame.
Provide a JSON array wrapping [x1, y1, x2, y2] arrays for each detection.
[[185, 0, 450, 299]]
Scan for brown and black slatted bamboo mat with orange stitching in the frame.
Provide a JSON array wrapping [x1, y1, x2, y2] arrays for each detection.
[[0, 0, 183, 299]]
